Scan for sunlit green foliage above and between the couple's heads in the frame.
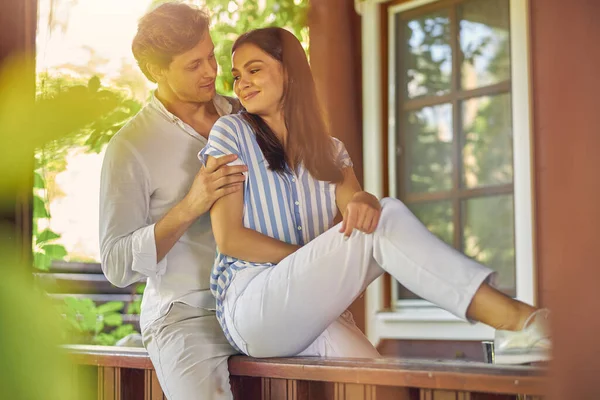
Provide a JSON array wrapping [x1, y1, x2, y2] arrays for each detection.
[[151, 0, 309, 95]]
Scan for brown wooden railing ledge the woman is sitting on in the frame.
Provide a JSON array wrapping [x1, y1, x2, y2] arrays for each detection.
[[64, 345, 547, 396]]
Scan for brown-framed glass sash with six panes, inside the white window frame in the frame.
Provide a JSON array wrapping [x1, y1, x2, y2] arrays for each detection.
[[390, 0, 516, 300]]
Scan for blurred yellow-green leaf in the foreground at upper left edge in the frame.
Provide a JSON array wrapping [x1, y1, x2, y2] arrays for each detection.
[[0, 59, 119, 198]]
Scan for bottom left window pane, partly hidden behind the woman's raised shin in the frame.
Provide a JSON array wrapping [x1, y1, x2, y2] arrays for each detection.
[[398, 201, 454, 300]]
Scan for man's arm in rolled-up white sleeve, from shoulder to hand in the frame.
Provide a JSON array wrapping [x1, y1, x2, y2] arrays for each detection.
[[100, 141, 245, 287]]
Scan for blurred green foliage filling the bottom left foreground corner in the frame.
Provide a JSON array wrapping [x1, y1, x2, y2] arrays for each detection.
[[0, 245, 95, 400]]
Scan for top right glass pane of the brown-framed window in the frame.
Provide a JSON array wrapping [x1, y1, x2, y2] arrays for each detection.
[[459, 0, 510, 89]]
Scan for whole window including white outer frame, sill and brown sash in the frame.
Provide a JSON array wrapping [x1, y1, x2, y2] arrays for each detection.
[[362, 0, 534, 341]]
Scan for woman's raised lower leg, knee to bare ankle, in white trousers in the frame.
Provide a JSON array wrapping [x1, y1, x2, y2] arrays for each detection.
[[374, 198, 535, 330]]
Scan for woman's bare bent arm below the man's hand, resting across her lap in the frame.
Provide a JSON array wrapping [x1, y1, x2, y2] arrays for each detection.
[[207, 157, 300, 264]]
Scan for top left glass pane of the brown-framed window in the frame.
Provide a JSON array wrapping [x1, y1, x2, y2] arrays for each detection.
[[398, 11, 452, 98]]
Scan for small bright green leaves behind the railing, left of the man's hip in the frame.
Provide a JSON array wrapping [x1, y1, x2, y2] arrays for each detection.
[[61, 297, 138, 346]]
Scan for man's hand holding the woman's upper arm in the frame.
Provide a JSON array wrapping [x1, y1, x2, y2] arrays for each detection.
[[184, 154, 248, 219]]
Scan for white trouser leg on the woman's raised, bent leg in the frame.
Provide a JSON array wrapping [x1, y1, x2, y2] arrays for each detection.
[[223, 198, 492, 357]]
